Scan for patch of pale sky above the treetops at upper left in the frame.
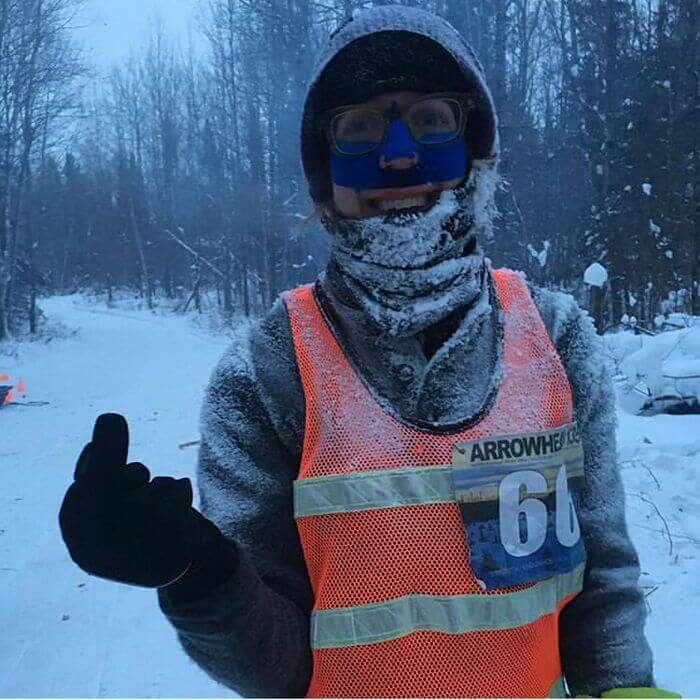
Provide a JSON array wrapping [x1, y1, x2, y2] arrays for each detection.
[[76, 0, 201, 69]]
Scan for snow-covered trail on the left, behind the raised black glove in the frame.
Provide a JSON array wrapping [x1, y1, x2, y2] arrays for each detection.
[[0, 297, 231, 697]]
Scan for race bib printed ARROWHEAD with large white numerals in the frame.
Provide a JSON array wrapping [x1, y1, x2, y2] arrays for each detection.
[[452, 423, 586, 590]]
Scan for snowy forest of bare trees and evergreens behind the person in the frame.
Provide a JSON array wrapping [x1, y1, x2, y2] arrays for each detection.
[[0, 0, 700, 341]]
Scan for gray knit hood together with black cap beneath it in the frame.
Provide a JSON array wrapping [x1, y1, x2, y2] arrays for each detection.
[[301, 5, 498, 202]]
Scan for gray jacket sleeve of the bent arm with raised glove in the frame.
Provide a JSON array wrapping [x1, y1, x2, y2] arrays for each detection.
[[158, 301, 312, 697]]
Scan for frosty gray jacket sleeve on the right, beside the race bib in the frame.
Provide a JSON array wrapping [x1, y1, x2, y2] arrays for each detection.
[[535, 290, 654, 696]]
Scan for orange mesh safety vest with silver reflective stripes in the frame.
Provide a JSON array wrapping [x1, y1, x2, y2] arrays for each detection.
[[285, 270, 583, 697]]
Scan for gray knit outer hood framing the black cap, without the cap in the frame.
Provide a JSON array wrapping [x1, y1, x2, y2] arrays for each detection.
[[301, 5, 498, 203]]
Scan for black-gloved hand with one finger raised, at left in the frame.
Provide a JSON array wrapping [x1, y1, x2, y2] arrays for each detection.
[[59, 413, 236, 587]]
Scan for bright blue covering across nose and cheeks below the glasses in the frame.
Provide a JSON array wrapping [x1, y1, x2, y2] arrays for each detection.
[[331, 115, 467, 190]]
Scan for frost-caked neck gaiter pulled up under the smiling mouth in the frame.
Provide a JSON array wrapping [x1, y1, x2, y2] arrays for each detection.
[[324, 164, 496, 337]]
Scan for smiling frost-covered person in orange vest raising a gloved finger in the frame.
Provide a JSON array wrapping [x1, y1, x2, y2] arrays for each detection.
[[60, 6, 662, 697]]
